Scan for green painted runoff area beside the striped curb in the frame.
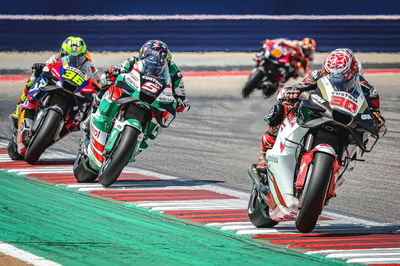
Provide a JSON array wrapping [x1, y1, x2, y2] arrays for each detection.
[[0, 171, 345, 266]]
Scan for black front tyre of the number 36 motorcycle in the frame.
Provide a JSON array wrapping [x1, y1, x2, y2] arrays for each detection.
[[24, 110, 63, 164]]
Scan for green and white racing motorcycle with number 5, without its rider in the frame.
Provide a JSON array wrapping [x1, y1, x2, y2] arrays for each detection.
[[74, 56, 177, 186]]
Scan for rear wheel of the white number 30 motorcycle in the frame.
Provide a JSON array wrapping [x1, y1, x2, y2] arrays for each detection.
[[247, 188, 278, 228]]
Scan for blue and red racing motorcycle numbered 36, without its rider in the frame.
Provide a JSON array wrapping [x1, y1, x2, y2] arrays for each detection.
[[8, 55, 96, 164]]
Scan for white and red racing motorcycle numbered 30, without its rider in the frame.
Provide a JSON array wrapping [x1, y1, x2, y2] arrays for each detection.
[[248, 77, 379, 233]]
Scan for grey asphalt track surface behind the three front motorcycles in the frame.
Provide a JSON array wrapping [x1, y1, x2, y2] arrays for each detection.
[[0, 54, 400, 227]]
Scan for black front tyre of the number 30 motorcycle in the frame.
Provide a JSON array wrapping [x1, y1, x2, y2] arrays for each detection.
[[296, 152, 334, 233]]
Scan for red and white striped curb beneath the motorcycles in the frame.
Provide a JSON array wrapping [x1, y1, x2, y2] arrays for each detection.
[[0, 143, 400, 265]]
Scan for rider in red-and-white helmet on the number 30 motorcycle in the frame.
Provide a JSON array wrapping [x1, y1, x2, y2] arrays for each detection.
[[257, 48, 386, 171]]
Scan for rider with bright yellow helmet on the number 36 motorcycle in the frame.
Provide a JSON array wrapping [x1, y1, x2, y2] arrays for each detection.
[[10, 36, 99, 129]]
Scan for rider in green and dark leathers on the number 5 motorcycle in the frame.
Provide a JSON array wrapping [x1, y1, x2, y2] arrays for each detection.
[[82, 40, 190, 155]]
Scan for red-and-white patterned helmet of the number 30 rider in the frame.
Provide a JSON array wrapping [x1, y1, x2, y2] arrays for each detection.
[[323, 48, 360, 92]]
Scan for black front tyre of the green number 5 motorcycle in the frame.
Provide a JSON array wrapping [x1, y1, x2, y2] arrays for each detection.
[[99, 127, 140, 187]]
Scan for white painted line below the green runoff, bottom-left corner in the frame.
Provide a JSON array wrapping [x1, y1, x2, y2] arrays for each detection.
[[0, 242, 61, 266]]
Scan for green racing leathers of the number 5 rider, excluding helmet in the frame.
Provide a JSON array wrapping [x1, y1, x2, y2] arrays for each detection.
[[86, 57, 190, 156]]
